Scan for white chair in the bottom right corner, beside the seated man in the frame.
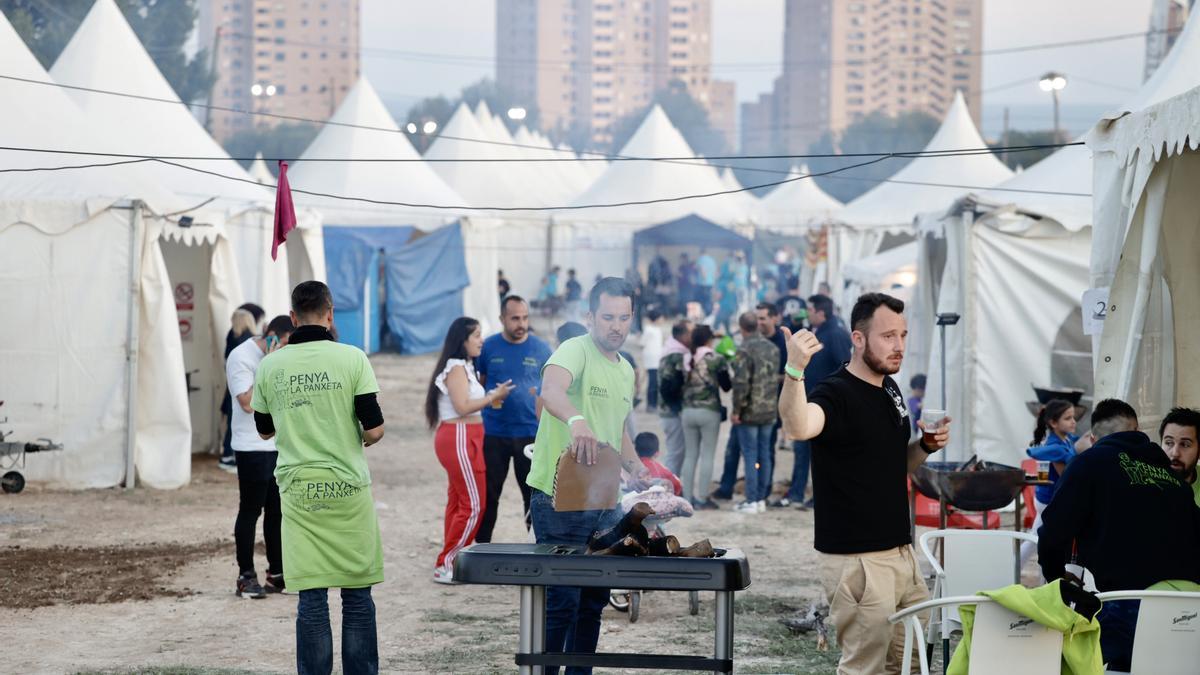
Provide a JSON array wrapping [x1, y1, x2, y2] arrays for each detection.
[[1096, 591, 1200, 675]]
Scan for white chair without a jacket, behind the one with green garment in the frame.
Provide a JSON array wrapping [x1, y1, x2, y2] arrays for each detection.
[[919, 530, 1038, 653]]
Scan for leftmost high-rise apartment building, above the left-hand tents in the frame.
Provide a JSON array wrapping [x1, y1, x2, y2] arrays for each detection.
[[197, 0, 360, 141]]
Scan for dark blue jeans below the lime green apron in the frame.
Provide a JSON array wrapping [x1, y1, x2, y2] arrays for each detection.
[[296, 586, 379, 675]]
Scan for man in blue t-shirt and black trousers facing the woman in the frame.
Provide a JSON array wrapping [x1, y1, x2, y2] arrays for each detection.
[[475, 295, 551, 543]]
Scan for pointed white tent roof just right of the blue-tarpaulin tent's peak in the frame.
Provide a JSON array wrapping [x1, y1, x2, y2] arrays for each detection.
[[425, 103, 530, 207]]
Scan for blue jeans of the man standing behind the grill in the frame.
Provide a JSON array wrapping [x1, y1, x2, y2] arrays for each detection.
[[529, 490, 620, 675]]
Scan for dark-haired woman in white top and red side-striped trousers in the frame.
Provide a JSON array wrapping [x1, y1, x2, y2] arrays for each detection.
[[425, 317, 512, 584]]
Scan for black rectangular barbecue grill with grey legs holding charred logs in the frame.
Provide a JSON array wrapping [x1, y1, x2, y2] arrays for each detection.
[[454, 544, 750, 674]]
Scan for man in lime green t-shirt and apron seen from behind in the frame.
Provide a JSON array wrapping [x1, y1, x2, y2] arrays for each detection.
[[251, 281, 383, 673]]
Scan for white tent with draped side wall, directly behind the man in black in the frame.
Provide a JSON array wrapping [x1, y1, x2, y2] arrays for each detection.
[[902, 147, 1092, 466]]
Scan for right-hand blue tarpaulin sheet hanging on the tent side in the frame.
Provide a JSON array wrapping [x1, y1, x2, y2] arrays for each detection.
[[384, 223, 470, 354]]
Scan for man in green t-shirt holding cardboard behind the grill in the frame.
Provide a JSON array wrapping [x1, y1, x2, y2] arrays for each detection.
[[526, 276, 649, 673]]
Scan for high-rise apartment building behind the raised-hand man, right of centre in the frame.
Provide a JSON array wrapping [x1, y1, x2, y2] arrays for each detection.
[[743, 0, 983, 153]]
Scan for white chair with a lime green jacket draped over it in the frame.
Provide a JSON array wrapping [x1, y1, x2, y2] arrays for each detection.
[[888, 596, 1062, 675]]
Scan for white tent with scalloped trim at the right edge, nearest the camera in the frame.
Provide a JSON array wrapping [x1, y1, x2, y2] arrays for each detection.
[[1085, 84, 1200, 429]]
